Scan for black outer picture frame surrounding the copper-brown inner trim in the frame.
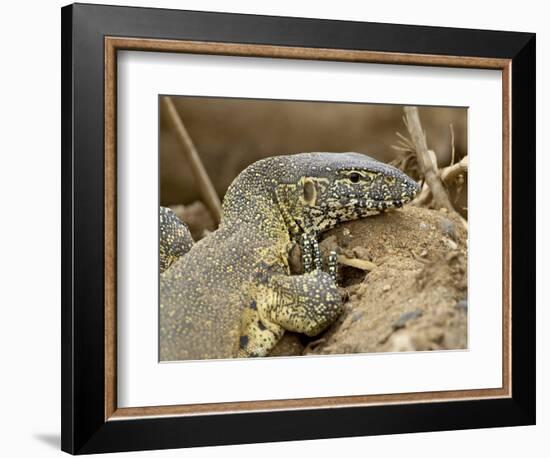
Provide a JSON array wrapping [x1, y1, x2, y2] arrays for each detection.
[[61, 4, 536, 454]]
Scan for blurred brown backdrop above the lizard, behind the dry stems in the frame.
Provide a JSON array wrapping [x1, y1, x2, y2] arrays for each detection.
[[159, 96, 467, 234]]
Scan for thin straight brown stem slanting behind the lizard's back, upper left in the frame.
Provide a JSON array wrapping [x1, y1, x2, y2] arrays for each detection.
[[162, 96, 222, 224]]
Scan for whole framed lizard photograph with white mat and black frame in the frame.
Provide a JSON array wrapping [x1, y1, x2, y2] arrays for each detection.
[[62, 4, 535, 454]]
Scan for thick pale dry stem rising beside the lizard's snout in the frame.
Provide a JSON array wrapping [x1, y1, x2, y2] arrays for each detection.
[[404, 107, 455, 212]]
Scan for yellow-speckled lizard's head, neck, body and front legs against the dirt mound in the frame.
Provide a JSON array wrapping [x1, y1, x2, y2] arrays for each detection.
[[160, 153, 418, 361]]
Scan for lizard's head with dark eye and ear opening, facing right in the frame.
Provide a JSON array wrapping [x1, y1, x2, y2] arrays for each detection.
[[278, 153, 419, 232]]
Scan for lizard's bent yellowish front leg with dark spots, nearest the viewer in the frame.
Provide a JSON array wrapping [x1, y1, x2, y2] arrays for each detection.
[[238, 269, 343, 357]]
